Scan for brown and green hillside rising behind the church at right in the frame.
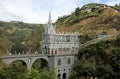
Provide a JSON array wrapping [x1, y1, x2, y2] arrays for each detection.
[[56, 3, 120, 36]]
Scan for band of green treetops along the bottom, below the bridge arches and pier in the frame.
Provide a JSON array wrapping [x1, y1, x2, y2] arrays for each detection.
[[0, 63, 57, 79]]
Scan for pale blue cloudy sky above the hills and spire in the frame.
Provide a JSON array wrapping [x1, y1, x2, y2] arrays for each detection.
[[0, 0, 120, 23]]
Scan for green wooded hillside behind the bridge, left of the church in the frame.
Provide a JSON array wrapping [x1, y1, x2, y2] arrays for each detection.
[[0, 21, 43, 54]]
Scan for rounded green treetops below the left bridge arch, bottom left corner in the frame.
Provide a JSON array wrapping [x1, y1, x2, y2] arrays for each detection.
[[0, 64, 27, 79]]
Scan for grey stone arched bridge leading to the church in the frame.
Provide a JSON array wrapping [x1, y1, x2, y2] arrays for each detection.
[[2, 54, 52, 70]]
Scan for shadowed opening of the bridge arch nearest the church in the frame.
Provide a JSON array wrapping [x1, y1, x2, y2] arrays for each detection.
[[32, 58, 49, 70]]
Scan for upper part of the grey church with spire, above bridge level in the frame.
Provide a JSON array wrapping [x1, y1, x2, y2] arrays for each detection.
[[42, 14, 79, 55]]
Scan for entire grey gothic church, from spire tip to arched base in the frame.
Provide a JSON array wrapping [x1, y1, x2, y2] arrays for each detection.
[[42, 14, 80, 79]]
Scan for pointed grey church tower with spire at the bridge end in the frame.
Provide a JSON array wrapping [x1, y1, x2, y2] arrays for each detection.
[[42, 13, 56, 55]]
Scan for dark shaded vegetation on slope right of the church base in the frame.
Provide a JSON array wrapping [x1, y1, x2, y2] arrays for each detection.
[[70, 36, 120, 79]]
